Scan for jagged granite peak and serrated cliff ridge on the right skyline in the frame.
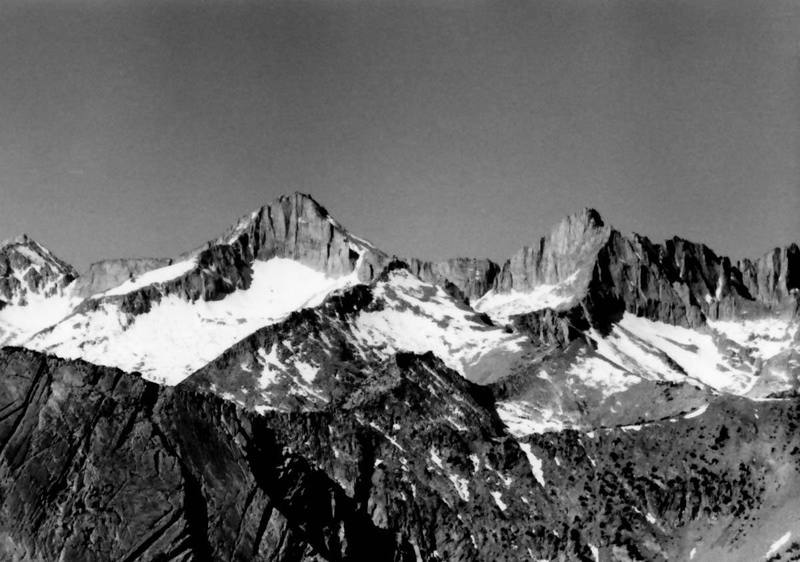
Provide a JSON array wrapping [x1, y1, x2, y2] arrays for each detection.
[[478, 209, 800, 327]]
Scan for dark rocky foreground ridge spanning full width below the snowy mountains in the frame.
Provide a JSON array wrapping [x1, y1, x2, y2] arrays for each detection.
[[0, 348, 800, 562]]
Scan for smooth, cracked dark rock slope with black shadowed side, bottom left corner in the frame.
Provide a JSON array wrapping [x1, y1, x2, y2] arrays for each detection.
[[0, 349, 422, 562]]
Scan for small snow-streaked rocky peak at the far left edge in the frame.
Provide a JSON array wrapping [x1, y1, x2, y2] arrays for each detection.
[[0, 234, 78, 305]]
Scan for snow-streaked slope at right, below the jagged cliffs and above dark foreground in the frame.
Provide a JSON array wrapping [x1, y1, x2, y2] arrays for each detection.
[[490, 313, 800, 436]]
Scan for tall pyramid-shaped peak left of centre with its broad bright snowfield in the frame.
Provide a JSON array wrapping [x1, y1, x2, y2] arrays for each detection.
[[18, 193, 387, 384]]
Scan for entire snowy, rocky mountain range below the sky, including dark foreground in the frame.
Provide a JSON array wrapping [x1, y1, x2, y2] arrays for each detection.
[[0, 193, 800, 561]]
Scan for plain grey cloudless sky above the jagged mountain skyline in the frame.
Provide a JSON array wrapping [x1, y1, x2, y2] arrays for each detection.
[[0, 0, 800, 269]]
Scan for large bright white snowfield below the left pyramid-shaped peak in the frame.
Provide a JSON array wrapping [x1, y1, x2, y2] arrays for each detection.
[[25, 258, 357, 384]]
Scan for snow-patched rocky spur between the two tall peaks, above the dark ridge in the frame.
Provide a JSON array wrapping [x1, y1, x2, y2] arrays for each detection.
[[187, 268, 532, 411]]
